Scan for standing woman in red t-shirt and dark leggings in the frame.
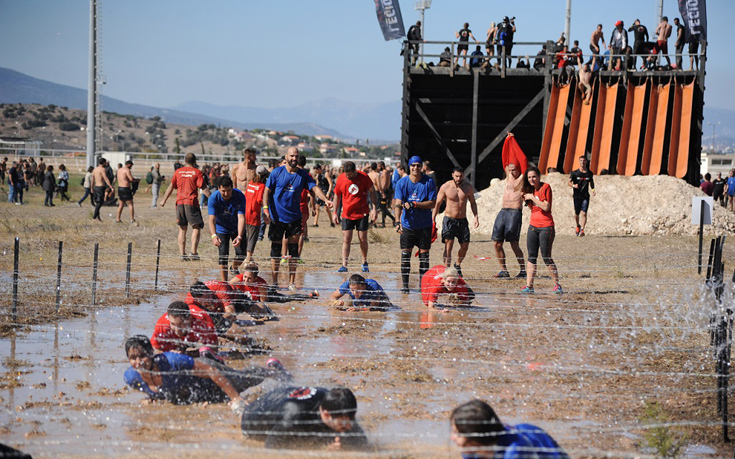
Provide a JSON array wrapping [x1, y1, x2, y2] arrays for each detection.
[[521, 166, 562, 293]]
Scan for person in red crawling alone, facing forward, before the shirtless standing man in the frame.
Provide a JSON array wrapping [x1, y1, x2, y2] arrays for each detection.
[[421, 265, 475, 309]]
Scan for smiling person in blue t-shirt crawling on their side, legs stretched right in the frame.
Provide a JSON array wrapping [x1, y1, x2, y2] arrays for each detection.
[[124, 335, 291, 414]]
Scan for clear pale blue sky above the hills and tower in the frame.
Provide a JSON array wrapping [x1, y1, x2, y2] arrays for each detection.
[[0, 0, 735, 108]]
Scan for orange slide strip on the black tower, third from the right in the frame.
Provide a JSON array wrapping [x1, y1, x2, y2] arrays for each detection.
[[617, 81, 646, 175]]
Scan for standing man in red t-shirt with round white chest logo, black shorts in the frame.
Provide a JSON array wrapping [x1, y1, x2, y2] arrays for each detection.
[[334, 161, 378, 273]]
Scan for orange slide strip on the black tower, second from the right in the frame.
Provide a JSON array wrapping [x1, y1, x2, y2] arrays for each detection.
[[641, 84, 671, 175]]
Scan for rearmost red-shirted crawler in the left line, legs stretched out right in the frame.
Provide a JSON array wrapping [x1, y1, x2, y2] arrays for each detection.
[[230, 262, 319, 315]]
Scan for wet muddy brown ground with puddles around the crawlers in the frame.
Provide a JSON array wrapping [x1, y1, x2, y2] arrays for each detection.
[[0, 181, 735, 458]]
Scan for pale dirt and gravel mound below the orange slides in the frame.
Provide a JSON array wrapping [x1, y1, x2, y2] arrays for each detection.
[[466, 173, 735, 236]]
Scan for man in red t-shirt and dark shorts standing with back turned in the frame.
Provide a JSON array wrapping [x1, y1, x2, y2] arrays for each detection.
[[160, 153, 209, 261]]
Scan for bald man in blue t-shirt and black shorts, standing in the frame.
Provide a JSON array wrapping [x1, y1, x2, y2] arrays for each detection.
[[263, 147, 334, 287]]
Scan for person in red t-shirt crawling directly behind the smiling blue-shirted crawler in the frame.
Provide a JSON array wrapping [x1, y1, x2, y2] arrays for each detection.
[[151, 301, 217, 357]]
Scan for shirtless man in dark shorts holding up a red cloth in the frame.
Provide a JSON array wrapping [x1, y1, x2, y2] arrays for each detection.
[[491, 163, 526, 279]]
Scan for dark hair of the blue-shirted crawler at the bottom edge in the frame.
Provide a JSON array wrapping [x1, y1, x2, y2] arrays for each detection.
[[450, 400, 505, 445]]
